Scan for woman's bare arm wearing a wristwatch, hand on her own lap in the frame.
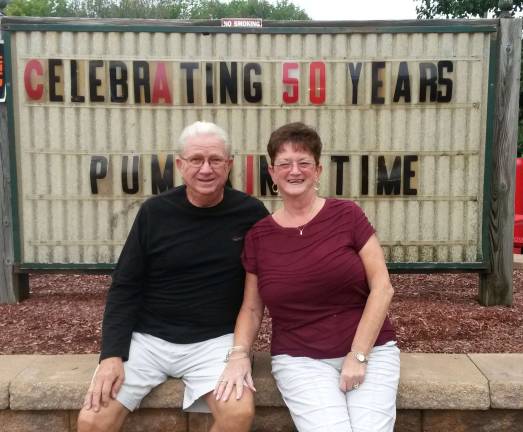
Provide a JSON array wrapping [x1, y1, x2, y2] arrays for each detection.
[[340, 234, 394, 391]]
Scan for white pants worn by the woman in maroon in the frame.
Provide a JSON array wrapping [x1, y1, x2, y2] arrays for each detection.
[[272, 342, 400, 432]]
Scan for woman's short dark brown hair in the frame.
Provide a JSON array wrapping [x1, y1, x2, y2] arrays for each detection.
[[267, 122, 322, 164]]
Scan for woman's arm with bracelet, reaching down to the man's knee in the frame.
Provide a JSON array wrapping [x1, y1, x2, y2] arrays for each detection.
[[214, 273, 264, 401]]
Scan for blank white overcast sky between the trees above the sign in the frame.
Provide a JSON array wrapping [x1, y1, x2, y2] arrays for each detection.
[[291, 0, 416, 20]]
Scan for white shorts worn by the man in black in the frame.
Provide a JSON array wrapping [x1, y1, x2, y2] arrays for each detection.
[[116, 332, 233, 412]]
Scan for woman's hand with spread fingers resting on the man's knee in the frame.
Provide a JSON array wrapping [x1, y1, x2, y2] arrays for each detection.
[[213, 356, 256, 401]]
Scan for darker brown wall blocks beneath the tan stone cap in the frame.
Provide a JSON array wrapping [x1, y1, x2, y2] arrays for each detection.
[[0, 407, 523, 432]]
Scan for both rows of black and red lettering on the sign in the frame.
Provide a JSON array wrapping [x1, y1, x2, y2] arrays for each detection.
[[23, 58, 455, 198]]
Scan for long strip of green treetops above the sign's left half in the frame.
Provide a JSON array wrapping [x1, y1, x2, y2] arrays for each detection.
[[4, 0, 310, 20]]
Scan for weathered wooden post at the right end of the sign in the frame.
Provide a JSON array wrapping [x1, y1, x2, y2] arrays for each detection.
[[479, 18, 521, 306]]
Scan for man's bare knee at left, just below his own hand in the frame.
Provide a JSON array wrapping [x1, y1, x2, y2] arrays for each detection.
[[78, 399, 129, 432]]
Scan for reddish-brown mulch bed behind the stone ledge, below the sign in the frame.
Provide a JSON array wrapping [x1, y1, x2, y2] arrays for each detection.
[[0, 271, 523, 354]]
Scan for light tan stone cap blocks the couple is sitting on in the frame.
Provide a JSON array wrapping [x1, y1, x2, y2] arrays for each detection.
[[0, 353, 523, 411]]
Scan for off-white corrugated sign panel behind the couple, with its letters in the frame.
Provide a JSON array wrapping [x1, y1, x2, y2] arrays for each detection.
[[11, 27, 490, 264]]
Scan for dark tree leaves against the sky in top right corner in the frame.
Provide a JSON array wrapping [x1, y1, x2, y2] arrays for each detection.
[[416, 0, 523, 19]]
